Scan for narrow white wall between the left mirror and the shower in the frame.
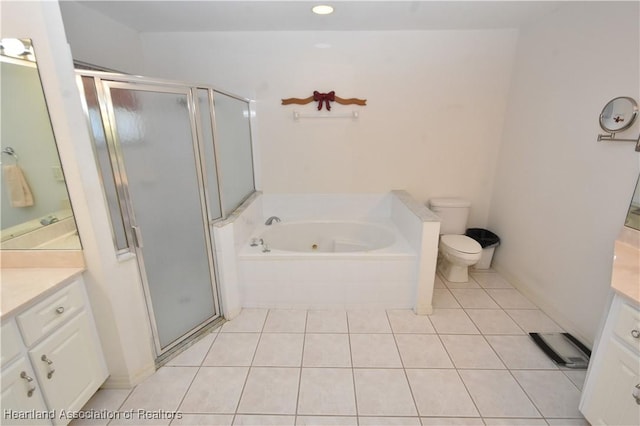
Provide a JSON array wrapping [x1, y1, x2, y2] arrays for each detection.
[[0, 1, 155, 387]]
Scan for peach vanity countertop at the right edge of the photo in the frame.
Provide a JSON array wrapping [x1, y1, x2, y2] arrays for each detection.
[[611, 227, 640, 305]]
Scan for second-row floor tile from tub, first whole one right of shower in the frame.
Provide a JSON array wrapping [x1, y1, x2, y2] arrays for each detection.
[[202, 333, 260, 367]]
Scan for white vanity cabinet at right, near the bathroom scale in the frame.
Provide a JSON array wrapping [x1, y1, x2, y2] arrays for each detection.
[[580, 294, 640, 426]]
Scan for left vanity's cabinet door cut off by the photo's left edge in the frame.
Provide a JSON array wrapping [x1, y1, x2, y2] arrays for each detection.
[[0, 357, 51, 425]]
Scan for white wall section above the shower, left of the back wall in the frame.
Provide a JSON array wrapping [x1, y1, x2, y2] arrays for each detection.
[[60, 1, 144, 74]]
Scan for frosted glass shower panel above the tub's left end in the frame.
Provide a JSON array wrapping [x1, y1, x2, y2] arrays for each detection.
[[213, 92, 255, 215]]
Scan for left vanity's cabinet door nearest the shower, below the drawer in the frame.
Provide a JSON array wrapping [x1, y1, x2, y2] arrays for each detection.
[[29, 310, 106, 424]]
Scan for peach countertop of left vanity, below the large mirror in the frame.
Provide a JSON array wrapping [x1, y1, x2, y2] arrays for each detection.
[[0, 268, 84, 319]]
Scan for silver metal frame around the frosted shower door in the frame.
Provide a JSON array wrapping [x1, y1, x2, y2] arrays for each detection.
[[76, 70, 228, 358]]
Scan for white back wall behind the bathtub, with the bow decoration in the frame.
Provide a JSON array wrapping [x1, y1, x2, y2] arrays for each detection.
[[141, 30, 517, 225]]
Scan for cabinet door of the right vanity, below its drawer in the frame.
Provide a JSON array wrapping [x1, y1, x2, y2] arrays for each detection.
[[584, 339, 640, 426]]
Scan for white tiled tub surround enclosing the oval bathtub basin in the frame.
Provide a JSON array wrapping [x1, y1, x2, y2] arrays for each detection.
[[214, 191, 440, 318]]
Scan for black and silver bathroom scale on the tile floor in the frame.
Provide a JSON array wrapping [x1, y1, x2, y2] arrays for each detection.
[[529, 333, 591, 369]]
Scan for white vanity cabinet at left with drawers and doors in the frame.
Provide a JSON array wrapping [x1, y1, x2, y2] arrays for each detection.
[[0, 278, 108, 425]]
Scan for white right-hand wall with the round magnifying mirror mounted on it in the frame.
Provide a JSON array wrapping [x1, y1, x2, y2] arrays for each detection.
[[488, 2, 640, 342]]
